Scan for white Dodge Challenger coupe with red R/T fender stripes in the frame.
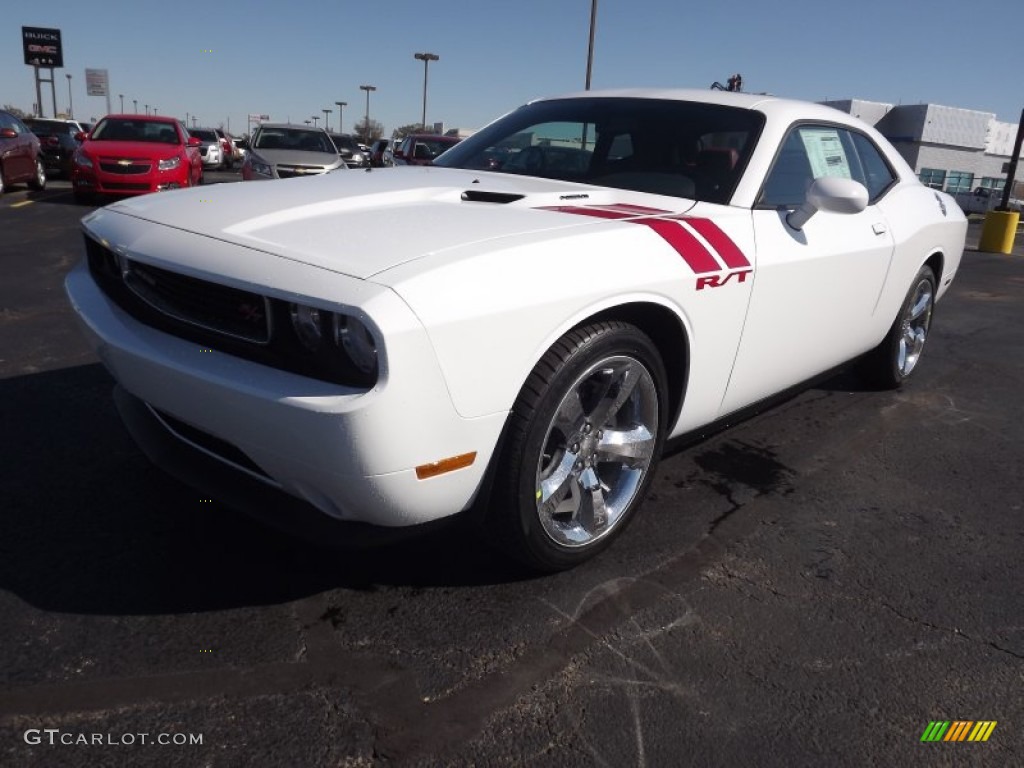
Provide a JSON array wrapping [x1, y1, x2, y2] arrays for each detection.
[[67, 90, 967, 570]]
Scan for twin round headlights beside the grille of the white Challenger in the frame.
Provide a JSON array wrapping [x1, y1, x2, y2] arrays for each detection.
[[288, 304, 378, 386]]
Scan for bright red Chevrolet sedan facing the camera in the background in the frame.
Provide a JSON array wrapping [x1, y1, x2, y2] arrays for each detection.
[[72, 115, 203, 203]]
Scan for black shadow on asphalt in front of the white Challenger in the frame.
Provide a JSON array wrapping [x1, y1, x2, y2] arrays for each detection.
[[0, 364, 521, 614]]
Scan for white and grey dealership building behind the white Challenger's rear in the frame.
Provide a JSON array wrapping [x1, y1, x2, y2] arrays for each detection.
[[822, 99, 1024, 197]]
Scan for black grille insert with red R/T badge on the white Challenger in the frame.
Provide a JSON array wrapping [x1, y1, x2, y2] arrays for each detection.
[[124, 261, 270, 344]]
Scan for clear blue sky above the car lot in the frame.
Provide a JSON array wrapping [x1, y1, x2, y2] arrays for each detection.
[[0, 0, 1024, 134]]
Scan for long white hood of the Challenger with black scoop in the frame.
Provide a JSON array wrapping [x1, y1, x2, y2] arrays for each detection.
[[99, 167, 694, 280]]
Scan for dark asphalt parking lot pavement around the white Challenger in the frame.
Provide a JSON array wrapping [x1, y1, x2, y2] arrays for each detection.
[[0, 174, 1024, 768]]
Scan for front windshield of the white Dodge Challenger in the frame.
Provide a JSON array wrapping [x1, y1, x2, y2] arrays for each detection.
[[434, 97, 764, 203]]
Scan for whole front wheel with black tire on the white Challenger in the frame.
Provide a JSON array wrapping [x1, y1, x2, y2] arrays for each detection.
[[485, 322, 668, 571]]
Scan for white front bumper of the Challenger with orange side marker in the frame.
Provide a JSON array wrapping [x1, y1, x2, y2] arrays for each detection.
[[66, 263, 506, 528]]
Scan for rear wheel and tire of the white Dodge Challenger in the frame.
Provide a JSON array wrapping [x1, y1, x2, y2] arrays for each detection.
[[861, 266, 936, 389]]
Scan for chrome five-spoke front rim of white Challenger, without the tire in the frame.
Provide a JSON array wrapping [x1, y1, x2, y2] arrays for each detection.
[[536, 355, 659, 547]]
